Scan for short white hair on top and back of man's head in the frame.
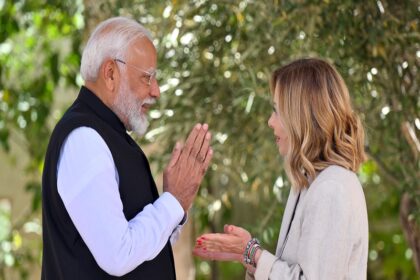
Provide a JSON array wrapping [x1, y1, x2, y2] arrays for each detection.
[[80, 17, 153, 82]]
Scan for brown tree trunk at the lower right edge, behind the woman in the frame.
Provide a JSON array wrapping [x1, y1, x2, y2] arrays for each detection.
[[400, 193, 420, 275]]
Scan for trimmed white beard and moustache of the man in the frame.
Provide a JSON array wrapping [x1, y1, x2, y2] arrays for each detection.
[[112, 79, 156, 137]]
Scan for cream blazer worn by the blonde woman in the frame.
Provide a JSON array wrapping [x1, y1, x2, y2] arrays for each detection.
[[246, 166, 368, 280]]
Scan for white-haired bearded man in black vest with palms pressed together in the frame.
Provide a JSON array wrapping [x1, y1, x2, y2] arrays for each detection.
[[41, 17, 213, 279]]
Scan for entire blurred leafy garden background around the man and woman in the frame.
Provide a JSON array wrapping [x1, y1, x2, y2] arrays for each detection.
[[0, 0, 420, 280]]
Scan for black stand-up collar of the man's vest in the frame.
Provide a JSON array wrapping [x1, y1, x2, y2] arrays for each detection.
[[78, 86, 126, 134]]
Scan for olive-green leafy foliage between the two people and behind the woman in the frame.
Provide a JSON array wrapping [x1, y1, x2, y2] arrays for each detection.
[[132, 1, 420, 279]]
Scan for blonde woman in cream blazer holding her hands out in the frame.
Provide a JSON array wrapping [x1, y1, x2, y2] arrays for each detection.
[[194, 58, 368, 280]]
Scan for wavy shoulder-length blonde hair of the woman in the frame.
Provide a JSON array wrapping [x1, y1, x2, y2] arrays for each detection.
[[270, 58, 366, 190]]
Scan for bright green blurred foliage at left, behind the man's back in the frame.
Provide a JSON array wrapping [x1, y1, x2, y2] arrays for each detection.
[[0, 0, 83, 279]]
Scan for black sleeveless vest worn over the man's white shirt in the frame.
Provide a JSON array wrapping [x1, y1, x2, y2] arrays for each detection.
[[41, 87, 176, 280]]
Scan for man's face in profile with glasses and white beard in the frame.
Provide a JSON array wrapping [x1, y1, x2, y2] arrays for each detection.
[[113, 38, 160, 136]]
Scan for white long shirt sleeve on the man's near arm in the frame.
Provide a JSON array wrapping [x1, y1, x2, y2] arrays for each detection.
[[57, 127, 184, 276]]
